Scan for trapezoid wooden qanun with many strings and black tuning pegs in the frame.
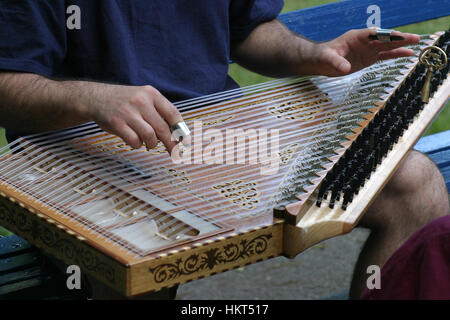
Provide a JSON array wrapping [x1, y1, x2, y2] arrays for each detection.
[[0, 32, 450, 296]]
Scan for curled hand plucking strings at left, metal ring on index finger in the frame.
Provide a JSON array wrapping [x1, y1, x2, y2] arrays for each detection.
[[85, 85, 183, 153]]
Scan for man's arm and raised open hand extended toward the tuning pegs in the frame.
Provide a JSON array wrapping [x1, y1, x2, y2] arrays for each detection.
[[231, 20, 419, 77]]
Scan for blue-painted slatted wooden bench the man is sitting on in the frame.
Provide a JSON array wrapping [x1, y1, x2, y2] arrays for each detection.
[[0, 0, 450, 299]]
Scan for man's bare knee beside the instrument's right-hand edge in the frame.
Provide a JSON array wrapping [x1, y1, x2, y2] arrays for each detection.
[[360, 151, 449, 230]]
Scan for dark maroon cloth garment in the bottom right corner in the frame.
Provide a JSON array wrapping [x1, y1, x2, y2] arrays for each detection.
[[361, 215, 450, 300]]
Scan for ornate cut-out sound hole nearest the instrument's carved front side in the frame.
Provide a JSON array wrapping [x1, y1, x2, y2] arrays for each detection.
[[213, 180, 259, 210]]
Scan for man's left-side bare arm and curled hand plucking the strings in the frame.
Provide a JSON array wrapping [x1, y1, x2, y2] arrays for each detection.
[[0, 72, 182, 152]]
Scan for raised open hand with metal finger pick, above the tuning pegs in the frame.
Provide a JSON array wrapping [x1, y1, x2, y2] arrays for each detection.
[[313, 29, 420, 76]]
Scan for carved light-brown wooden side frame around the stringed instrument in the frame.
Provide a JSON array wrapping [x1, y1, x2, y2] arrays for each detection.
[[0, 33, 450, 297]]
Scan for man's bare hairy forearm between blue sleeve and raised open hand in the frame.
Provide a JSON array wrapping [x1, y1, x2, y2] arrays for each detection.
[[231, 20, 320, 77]]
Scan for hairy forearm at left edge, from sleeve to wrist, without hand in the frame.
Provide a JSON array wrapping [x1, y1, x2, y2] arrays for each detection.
[[0, 72, 94, 132]]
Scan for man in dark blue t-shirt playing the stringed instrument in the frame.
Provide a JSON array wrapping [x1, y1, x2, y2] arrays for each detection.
[[0, 0, 448, 297]]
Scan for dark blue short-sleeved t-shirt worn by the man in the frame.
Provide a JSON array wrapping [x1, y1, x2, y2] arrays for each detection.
[[0, 0, 283, 101]]
